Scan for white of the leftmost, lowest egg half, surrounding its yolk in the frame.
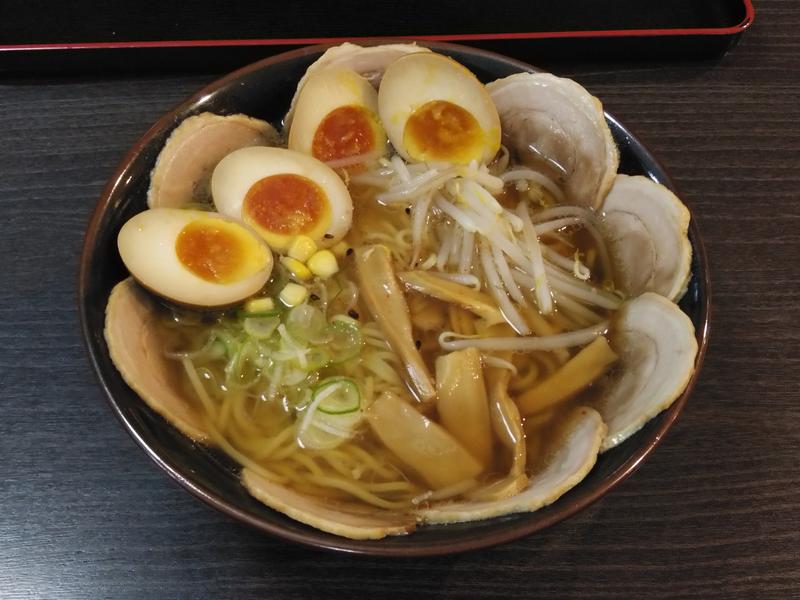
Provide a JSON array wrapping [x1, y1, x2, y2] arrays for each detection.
[[117, 208, 273, 307]]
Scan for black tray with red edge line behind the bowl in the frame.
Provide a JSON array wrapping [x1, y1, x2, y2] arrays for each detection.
[[0, 0, 755, 71]]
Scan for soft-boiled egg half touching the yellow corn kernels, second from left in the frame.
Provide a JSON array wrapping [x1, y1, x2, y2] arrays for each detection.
[[211, 146, 353, 251]]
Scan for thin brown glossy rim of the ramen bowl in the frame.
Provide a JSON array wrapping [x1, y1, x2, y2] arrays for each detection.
[[77, 38, 712, 556]]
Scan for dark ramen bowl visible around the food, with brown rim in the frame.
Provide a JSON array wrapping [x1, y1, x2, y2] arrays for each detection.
[[78, 44, 710, 556]]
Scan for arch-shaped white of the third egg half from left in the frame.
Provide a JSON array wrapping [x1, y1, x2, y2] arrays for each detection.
[[289, 67, 386, 158]]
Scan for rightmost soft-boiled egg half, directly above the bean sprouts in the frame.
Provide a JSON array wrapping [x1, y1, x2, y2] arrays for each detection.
[[378, 52, 500, 164]]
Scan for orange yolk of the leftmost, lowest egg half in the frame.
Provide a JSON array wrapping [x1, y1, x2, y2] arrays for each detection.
[[175, 219, 263, 283]]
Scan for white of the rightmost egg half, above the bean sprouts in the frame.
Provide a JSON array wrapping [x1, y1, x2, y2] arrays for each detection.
[[378, 52, 500, 163]]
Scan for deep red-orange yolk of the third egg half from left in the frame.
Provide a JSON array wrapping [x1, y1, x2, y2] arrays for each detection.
[[311, 106, 376, 162]]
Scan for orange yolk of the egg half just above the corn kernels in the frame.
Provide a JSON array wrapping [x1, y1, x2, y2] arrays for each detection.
[[242, 173, 330, 241]]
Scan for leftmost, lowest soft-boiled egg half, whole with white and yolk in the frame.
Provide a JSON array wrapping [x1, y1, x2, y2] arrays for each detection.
[[117, 208, 272, 307]]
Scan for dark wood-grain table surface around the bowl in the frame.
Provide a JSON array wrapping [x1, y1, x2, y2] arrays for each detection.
[[0, 0, 800, 599]]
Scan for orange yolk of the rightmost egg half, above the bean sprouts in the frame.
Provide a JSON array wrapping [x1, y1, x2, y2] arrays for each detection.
[[403, 100, 483, 164]]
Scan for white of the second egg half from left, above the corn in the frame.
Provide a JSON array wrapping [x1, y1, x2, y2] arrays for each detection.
[[211, 146, 353, 251]]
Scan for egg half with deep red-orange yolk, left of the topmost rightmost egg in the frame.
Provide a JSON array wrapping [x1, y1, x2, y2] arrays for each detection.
[[289, 67, 387, 166]]
